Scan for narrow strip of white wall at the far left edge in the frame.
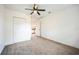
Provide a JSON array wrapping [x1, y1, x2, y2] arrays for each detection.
[[0, 5, 5, 54]]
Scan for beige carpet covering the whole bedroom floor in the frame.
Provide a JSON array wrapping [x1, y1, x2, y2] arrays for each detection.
[[2, 37, 79, 55]]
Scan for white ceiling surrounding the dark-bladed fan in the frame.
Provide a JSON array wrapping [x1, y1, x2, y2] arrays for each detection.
[[5, 4, 72, 18]]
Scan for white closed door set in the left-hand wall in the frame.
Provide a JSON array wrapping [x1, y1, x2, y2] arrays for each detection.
[[13, 17, 27, 42]]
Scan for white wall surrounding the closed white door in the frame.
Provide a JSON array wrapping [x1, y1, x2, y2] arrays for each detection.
[[5, 8, 31, 45]]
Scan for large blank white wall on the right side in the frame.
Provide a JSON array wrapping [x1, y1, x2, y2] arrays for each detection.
[[41, 5, 79, 48]]
